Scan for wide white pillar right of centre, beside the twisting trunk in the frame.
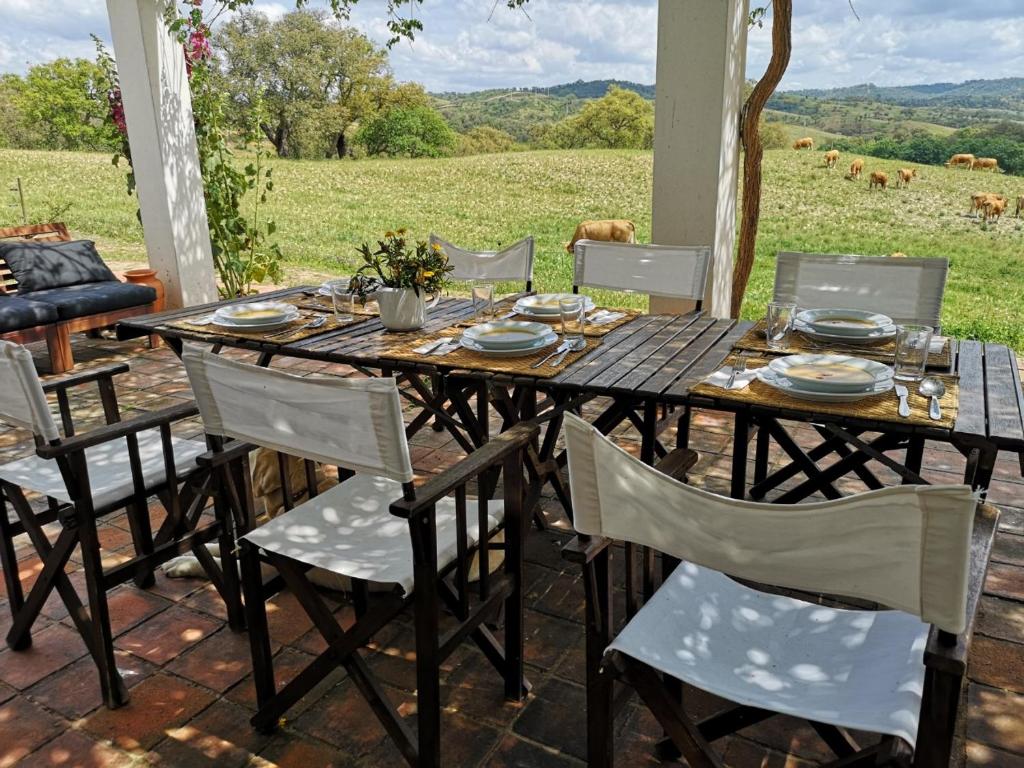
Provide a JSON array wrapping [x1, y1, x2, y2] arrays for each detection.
[[651, 0, 748, 317]]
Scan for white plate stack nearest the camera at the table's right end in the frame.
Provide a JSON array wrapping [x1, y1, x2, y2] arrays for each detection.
[[757, 354, 893, 402]]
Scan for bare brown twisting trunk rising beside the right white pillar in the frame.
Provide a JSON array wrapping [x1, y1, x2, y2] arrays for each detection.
[[730, 0, 793, 317]]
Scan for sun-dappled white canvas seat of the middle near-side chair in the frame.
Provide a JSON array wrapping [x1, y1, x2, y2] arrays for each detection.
[[243, 474, 505, 594]]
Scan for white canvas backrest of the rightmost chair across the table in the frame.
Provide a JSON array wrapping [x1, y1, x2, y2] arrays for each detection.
[[775, 253, 949, 329]]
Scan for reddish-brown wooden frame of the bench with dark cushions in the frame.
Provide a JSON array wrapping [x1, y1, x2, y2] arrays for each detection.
[[0, 222, 159, 374]]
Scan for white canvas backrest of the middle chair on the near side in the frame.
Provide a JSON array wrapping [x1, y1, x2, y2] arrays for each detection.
[[181, 345, 413, 482]]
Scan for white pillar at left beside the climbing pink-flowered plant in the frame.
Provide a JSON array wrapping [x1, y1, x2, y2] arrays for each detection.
[[106, 0, 217, 308]]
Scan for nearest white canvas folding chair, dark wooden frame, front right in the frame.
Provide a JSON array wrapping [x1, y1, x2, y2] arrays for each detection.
[[563, 417, 998, 768]]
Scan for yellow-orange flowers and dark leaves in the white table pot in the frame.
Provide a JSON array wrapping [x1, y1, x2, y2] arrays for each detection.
[[352, 228, 455, 297]]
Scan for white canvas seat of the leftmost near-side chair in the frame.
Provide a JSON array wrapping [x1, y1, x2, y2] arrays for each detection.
[[0, 429, 207, 509]]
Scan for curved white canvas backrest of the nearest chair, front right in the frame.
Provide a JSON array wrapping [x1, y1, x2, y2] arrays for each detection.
[[565, 414, 977, 634]]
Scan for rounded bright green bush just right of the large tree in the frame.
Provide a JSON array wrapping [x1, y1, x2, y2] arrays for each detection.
[[355, 104, 456, 158]]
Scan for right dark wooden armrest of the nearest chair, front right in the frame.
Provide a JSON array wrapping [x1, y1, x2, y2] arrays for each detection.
[[925, 504, 999, 676]]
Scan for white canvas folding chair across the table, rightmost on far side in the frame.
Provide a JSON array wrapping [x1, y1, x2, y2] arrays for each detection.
[[751, 252, 949, 501]]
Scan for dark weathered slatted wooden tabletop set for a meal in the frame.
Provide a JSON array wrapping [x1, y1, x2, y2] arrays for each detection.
[[118, 289, 1024, 453]]
